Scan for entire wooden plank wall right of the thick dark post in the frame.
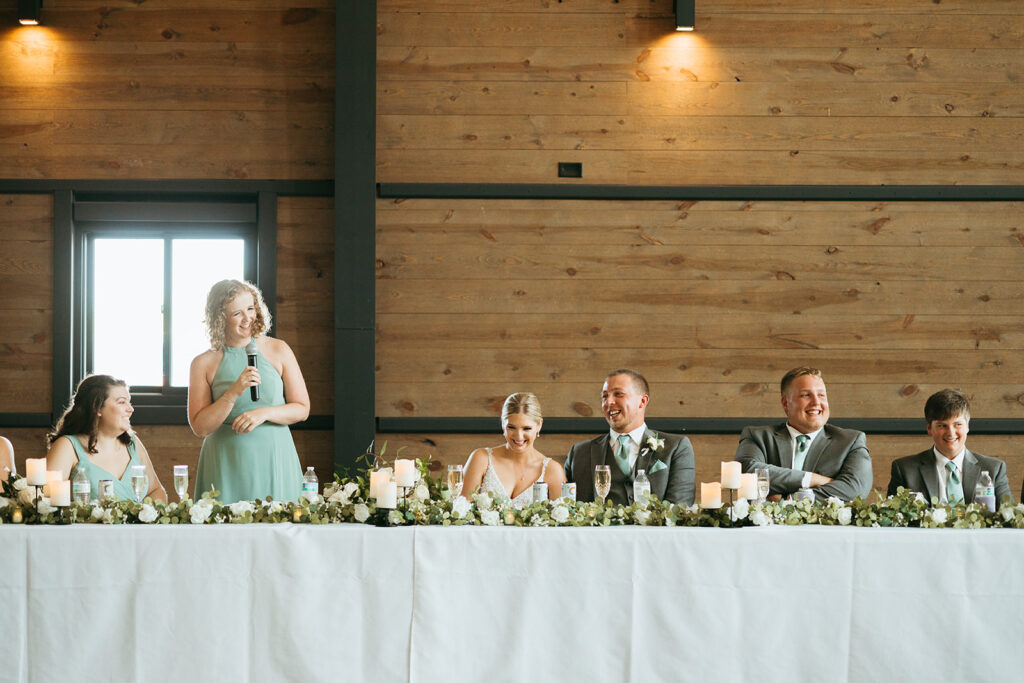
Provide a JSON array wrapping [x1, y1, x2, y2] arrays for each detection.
[[377, 0, 1024, 501]]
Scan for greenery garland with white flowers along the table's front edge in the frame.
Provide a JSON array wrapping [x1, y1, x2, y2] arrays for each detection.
[[0, 461, 1024, 528]]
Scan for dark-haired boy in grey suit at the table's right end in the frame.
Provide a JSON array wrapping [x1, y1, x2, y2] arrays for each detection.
[[889, 389, 1013, 506]]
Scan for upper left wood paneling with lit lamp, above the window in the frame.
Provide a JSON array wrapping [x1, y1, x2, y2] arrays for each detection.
[[0, 0, 334, 180]]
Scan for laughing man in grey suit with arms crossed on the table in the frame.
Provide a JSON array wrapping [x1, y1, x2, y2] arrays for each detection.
[[735, 368, 871, 501]]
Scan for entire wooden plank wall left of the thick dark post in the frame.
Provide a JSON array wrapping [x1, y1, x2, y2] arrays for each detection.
[[0, 0, 334, 486]]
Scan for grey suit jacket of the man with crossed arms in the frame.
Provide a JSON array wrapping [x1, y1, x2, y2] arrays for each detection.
[[735, 422, 871, 501]]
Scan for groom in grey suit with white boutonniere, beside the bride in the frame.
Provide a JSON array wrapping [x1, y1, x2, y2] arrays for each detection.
[[565, 370, 694, 505]]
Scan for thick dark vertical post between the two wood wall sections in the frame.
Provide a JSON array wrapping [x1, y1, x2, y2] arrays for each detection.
[[334, 0, 377, 469]]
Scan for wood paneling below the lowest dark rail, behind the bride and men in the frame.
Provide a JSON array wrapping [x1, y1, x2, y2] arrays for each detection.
[[377, 432, 1024, 500]]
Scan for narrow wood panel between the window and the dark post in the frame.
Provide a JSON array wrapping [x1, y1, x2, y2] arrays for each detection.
[[273, 197, 334, 415]]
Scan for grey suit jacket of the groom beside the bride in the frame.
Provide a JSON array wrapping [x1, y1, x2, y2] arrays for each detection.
[[565, 429, 696, 505]]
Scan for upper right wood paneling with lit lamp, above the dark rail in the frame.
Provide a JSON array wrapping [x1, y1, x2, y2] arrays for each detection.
[[377, 0, 1024, 184]]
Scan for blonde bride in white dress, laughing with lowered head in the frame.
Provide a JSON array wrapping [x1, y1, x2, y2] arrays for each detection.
[[462, 391, 565, 508]]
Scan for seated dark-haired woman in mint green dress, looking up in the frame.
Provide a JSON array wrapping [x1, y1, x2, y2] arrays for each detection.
[[46, 375, 167, 501]]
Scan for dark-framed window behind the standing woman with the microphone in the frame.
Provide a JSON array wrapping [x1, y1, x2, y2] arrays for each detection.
[[61, 195, 276, 424]]
